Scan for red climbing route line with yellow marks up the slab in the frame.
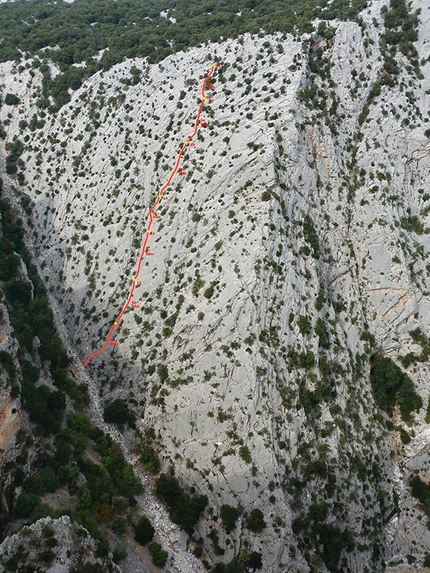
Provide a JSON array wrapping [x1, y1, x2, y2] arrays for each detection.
[[84, 64, 221, 366]]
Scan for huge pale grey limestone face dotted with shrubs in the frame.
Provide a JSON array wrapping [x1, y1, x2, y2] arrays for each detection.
[[0, 0, 430, 572]]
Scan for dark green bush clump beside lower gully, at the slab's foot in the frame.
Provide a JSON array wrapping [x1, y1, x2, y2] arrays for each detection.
[[155, 473, 208, 535]]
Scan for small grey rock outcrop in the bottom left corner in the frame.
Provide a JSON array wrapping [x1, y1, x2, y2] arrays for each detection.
[[0, 515, 120, 573]]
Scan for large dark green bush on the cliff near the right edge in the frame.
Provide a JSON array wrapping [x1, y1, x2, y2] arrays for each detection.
[[370, 355, 422, 422]]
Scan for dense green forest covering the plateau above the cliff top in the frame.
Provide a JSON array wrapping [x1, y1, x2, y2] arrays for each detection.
[[0, 0, 365, 91]]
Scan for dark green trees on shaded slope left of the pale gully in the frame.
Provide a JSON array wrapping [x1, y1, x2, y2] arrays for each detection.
[[0, 193, 142, 544]]
